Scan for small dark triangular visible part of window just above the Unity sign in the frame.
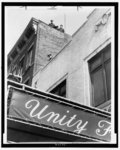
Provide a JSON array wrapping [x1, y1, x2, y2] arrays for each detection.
[[50, 80, 66, 97]]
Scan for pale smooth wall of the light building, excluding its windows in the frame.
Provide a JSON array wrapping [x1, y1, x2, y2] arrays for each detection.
[[32, 9, 111, 106]]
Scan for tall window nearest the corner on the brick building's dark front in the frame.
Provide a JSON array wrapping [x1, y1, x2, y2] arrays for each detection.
[[26, 44, 34, 69]]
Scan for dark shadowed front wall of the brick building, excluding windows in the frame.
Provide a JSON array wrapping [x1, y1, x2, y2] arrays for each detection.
[[7, 18, 37, 85]]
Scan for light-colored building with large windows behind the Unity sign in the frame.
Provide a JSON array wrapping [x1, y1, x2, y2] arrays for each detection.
[[32, 8, 112, 111]]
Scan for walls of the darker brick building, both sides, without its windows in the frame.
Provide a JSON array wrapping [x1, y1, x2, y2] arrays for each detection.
[[8, 18, 71, 85]]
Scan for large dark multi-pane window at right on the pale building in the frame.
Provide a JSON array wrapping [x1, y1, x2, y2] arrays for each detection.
[[89, 45, 111, 107]]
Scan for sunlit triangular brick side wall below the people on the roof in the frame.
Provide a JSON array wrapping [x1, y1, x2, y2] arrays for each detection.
[[34, 22, 71, 75]]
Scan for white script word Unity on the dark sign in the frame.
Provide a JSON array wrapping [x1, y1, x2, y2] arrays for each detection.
[[25, 99, 88, 134]]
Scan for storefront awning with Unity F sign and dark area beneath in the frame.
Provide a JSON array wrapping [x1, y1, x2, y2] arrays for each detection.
[[7, 80, 111, 143]]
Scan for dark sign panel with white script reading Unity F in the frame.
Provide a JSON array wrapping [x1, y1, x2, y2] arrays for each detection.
[[9, 87, 111, 141]]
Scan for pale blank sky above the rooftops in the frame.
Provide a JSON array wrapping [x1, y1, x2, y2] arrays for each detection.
[[5, 6, 94, 54]]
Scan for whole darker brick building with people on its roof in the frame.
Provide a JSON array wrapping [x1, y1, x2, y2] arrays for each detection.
[[8, 18, 71, 85]]
